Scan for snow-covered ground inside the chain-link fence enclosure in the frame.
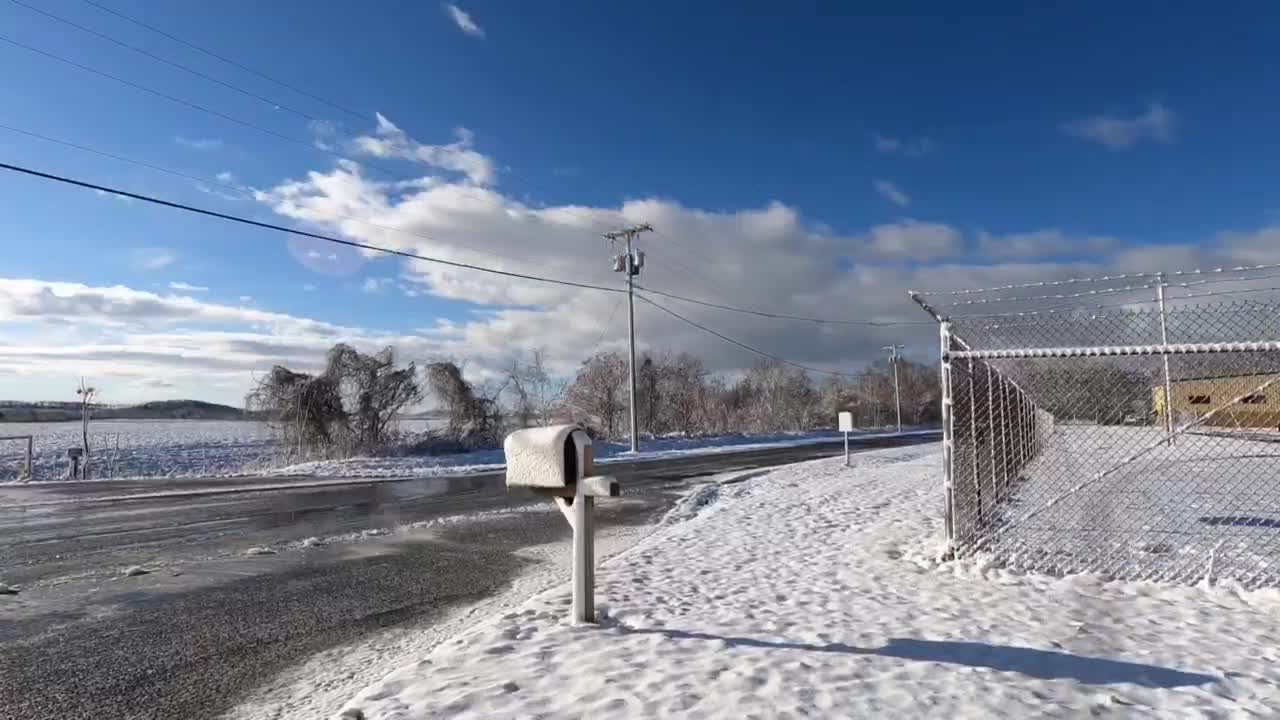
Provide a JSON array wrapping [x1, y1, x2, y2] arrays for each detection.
[[993, 425, 1280, 584]]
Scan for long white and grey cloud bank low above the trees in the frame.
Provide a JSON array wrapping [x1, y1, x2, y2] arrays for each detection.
[[10, 116, 1280, 397]]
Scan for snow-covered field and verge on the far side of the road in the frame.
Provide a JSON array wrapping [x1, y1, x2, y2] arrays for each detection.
[[0, 420, 921, 482]]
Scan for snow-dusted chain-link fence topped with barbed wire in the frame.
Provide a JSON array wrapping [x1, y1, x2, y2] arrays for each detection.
[[913, 266, 1280, 587]]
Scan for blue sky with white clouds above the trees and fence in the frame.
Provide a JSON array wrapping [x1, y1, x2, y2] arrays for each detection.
[[0, 0, 1280, 401]]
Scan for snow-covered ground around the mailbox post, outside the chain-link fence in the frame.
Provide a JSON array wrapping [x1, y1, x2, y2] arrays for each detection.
[[334, 446, 1280, 720]]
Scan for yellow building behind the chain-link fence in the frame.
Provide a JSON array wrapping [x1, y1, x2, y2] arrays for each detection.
[[1151, 373, 1280, 429]]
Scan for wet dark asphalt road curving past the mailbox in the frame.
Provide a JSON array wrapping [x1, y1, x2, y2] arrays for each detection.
[[0, 436, 937, 720]]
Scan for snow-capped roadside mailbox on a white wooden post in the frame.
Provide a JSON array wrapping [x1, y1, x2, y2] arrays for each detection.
[[502, 425, 622, 623]]
